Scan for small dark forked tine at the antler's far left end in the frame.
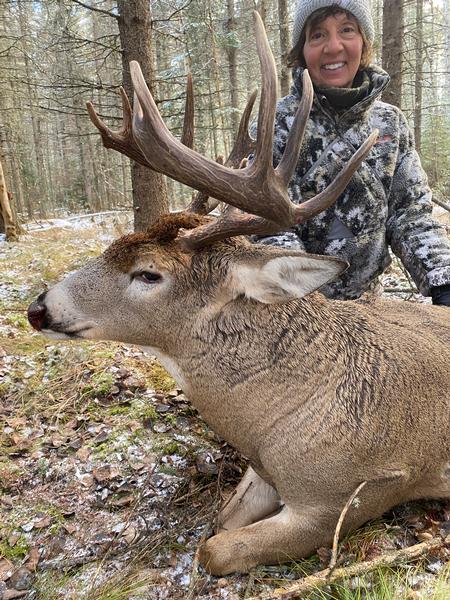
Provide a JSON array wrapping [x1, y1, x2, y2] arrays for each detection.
[[86, 87, 150, 167]]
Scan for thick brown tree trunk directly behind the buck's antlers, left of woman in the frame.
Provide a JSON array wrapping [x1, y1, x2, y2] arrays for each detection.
[[117, 0, 169, 231]]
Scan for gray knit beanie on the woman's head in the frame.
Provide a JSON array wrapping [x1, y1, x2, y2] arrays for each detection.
[[292, 0, 375, 46]]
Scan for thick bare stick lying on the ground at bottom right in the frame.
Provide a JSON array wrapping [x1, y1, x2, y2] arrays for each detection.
[[248, 538, 443, 600]]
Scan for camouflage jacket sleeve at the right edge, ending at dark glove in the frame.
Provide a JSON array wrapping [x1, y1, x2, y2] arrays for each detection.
[[387, 113, 450, 296]]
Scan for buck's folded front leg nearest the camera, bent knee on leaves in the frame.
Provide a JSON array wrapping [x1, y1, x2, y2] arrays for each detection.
[[199, 506, 334, 575]]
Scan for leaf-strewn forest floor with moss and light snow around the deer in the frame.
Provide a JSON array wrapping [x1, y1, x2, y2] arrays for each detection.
[[0, 216, 450, 600]]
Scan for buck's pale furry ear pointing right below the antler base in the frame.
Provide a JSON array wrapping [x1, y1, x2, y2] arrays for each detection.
[[232, 253, 348, 304]]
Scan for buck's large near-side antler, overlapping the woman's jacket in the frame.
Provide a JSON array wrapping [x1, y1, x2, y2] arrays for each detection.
[[88, 11, 378, 248]]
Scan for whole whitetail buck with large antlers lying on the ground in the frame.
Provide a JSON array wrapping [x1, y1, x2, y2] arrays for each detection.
[[29, 12, 450, 574]]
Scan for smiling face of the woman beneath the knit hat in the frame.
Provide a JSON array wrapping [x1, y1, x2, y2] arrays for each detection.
[[303, 13, 363, 87]]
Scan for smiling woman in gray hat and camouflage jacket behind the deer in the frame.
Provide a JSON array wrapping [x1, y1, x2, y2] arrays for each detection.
[[260, 0, 450, 306]]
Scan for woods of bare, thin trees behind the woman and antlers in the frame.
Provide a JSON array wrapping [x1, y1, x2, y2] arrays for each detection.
[[0, 0, 450, 230]]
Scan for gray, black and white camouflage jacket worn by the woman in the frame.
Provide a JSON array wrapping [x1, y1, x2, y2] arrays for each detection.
[[259, 66, 450, 300]]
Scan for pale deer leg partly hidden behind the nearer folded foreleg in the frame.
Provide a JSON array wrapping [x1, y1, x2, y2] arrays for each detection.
[[218, 467, 281, 531]]
